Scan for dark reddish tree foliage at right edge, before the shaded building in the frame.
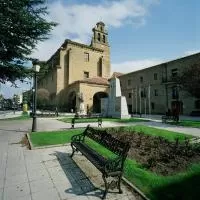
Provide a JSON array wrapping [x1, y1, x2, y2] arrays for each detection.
[[177, 64, 200, 98]]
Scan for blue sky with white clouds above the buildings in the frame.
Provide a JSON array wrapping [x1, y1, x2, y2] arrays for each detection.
[[1, 0, 200, 97]]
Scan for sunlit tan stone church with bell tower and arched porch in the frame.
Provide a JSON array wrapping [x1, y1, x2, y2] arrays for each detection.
[[38, 22, 110, 112]]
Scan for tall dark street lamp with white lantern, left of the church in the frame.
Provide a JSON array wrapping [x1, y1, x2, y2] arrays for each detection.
[[32, 62, 40, 132]]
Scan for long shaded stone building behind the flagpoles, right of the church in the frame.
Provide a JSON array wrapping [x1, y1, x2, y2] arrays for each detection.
[[119, 53, 200, 115]]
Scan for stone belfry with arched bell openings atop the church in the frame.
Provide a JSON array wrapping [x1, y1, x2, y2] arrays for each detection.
[[91, 22, 109, 50]]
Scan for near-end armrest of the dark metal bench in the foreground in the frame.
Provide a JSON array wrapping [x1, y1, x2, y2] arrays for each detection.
[[105, 157, 124, 173]]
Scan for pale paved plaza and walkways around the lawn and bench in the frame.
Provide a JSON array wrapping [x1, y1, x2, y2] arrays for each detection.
[[0, 116, 200, 200]]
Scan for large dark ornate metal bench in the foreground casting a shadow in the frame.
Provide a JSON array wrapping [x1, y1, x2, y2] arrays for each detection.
[[71, 125, 130, 199]]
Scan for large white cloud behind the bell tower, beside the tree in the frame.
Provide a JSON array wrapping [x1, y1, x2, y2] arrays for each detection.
[[33, 0, 158, 60]]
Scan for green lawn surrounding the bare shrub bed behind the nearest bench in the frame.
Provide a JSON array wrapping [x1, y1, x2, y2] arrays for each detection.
[[30, 125, 200, 200]]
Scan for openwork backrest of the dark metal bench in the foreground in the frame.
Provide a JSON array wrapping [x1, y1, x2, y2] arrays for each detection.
[[83, 126, 130, 157]]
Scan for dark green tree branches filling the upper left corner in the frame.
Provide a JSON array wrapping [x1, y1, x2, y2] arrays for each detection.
[[0, 0, 56, 83]]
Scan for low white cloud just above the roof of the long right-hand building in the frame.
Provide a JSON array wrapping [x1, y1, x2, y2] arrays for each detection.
[[112, 59, 164, 73]]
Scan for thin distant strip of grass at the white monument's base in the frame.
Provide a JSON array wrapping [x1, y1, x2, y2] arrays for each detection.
[[58, 117, 149, 123]]
